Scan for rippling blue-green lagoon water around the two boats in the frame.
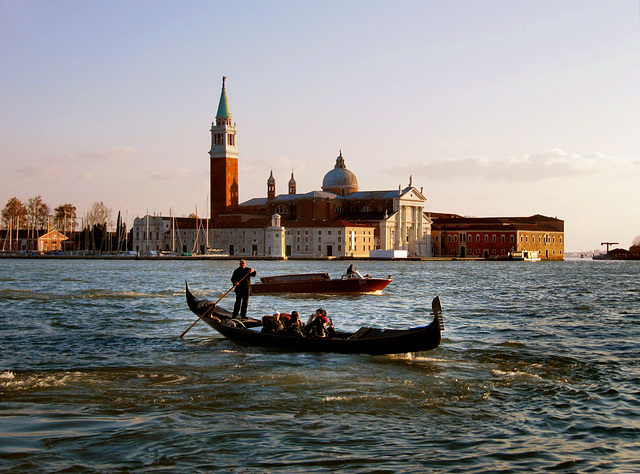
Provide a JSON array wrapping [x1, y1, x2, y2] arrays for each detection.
[[0, 259, 640, 473]]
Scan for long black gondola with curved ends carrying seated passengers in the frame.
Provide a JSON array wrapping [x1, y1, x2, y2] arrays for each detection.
[[186, 284, 444, 355]]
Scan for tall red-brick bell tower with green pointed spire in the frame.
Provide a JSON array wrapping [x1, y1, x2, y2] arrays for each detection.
[[209, 77, 238, 219]]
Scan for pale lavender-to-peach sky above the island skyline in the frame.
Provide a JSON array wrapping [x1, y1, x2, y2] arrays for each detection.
[[0, 0, 640, 252]]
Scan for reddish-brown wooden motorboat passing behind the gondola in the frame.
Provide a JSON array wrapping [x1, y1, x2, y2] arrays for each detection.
[[251, 270, 392, 295]]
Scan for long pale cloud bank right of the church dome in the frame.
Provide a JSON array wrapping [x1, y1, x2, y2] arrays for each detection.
[[389, 148, 640, 182]]
